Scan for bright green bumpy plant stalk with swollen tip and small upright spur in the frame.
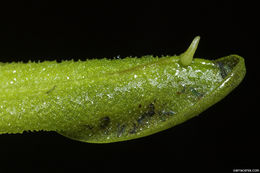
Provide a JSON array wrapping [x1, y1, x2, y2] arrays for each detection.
[[0, 36, 246, 143]]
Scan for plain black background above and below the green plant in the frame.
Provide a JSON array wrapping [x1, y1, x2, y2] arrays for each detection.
[[0, 0, 260, 172]]
